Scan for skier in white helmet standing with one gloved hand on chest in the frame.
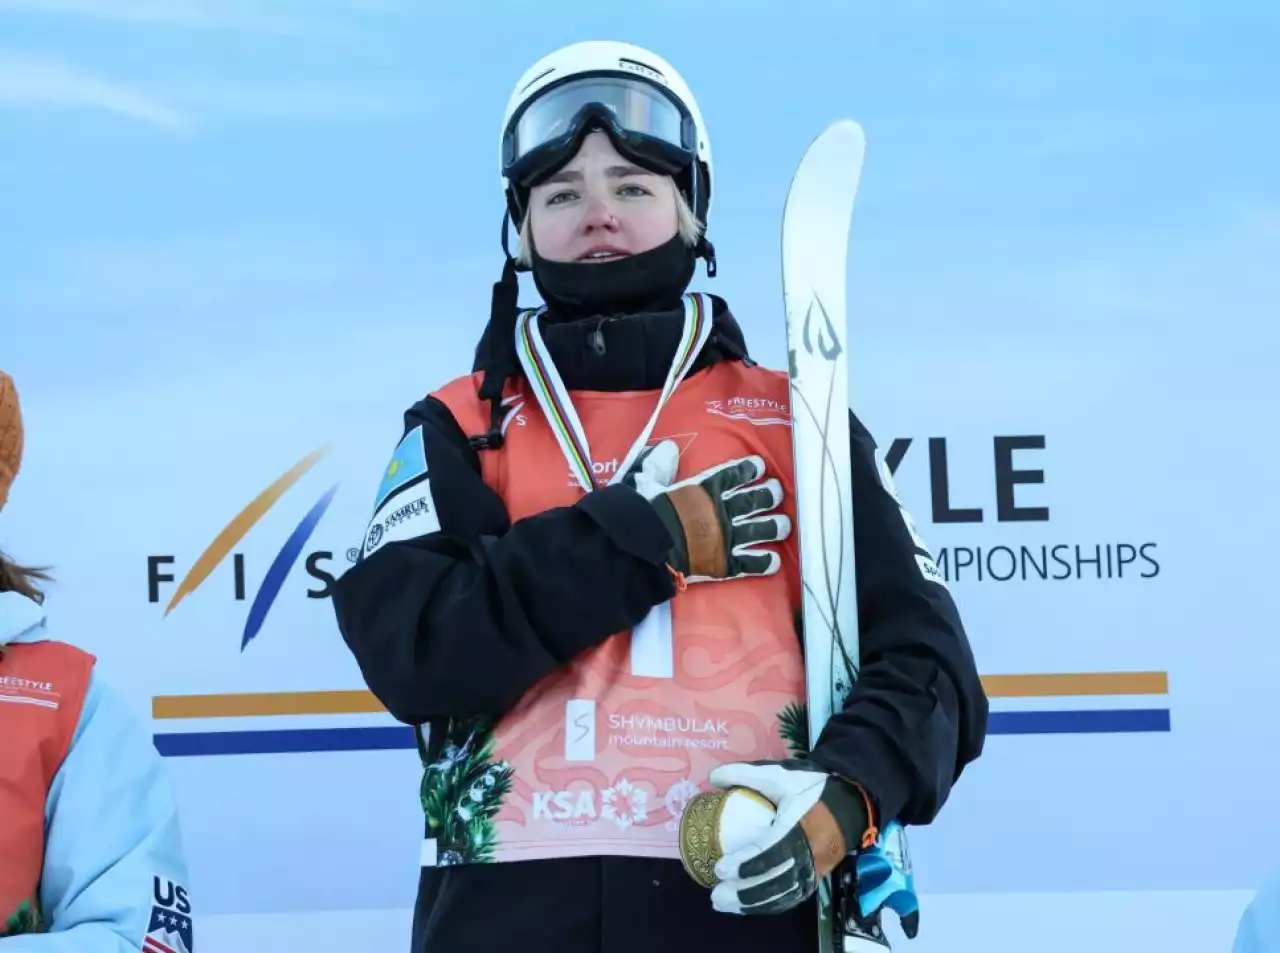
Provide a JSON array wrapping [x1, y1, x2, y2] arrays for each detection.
[[333, 42, 987, 953]]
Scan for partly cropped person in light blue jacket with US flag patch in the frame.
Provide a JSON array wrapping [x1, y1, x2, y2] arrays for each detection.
[[0, 371, 195, 953]]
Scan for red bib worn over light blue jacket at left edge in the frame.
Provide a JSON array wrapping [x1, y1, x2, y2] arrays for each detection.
[[0, 642, 95, 936]]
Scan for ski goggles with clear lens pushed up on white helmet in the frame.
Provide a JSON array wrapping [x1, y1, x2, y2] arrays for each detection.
[[502, 74, 698, 188]]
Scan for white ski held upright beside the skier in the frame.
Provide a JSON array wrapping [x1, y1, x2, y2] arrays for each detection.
[[782, 119, 918, 953]]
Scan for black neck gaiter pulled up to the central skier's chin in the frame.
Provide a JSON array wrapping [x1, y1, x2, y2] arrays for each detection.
[[532, 234, 698, 321]]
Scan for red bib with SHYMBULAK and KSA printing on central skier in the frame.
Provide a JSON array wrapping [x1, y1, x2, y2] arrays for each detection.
[[424, 350, 804, 863]]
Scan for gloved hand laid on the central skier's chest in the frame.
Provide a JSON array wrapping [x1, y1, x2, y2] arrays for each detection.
[[625, 440, 791, 582]]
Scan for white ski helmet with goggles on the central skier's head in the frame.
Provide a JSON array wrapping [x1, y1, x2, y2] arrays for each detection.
[[498, 40, 712, 234]]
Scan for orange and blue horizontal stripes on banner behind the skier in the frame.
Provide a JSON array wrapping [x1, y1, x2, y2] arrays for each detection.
[[151, 672, 1170, 757]]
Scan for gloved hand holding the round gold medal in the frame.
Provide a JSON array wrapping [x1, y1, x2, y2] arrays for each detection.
[[709, 760, 876, 913]]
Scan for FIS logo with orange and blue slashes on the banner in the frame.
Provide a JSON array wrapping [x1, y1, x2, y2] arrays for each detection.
[[147, 445, 345, 651]]
